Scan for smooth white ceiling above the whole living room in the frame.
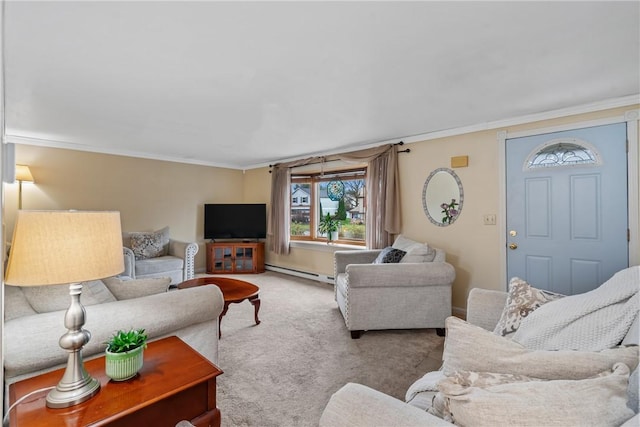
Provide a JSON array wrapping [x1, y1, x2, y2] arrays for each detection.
[[4, 1, 640, 169]]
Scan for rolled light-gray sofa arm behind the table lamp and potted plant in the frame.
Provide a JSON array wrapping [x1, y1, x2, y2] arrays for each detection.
[[4, 285, 224, 379]]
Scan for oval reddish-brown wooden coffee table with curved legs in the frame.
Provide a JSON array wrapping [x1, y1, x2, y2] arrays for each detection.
[[178, 276, 260, 338]]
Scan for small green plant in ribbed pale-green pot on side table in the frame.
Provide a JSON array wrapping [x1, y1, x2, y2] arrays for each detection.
[[105, 329, 147, 381]]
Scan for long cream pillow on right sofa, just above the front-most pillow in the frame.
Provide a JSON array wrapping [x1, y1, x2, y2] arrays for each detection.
[[442, 316, 638, 380]]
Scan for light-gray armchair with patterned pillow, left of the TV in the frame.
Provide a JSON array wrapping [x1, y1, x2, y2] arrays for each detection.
[[121, 227, 199, 285]]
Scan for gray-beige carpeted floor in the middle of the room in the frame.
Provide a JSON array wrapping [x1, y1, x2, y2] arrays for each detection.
[[212, 272, 444, 427]]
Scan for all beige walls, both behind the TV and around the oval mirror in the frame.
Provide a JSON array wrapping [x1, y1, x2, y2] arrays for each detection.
[[5, 106, 640, 307]]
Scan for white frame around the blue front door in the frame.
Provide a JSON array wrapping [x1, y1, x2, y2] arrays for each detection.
[[496, 110, 640, 290]]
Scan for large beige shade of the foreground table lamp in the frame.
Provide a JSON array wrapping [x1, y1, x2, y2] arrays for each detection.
[[5, 210, 124, 286]]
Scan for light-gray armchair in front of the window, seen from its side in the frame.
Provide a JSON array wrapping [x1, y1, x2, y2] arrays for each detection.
[[334, 236, 456, 338]]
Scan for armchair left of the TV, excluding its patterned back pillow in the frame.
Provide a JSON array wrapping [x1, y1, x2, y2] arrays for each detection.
[[121, 232, 198, 285]]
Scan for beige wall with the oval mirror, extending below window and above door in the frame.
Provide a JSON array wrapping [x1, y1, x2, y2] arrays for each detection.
[[252, 106, 640, 308]]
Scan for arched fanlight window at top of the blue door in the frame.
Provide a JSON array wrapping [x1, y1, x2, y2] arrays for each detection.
[[524, 138, 602, 171]]
